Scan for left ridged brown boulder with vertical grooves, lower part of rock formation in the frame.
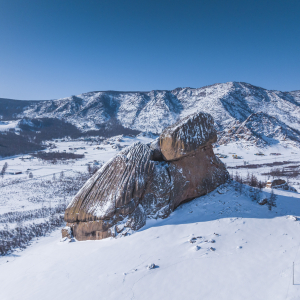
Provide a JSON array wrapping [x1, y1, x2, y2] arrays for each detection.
[[65, 143, 154, 240]]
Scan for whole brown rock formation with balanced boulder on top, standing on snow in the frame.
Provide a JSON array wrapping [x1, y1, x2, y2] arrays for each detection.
[[65, 113, 229, 240]]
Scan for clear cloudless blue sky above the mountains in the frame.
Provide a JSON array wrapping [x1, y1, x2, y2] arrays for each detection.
[[0, 0, 300, 100]]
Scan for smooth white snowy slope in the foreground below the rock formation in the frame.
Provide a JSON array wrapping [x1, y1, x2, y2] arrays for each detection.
[[0, 185, 300, 300]]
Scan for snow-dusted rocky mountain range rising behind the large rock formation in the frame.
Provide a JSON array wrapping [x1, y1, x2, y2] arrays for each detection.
[[0, 82, 300, 145]]
